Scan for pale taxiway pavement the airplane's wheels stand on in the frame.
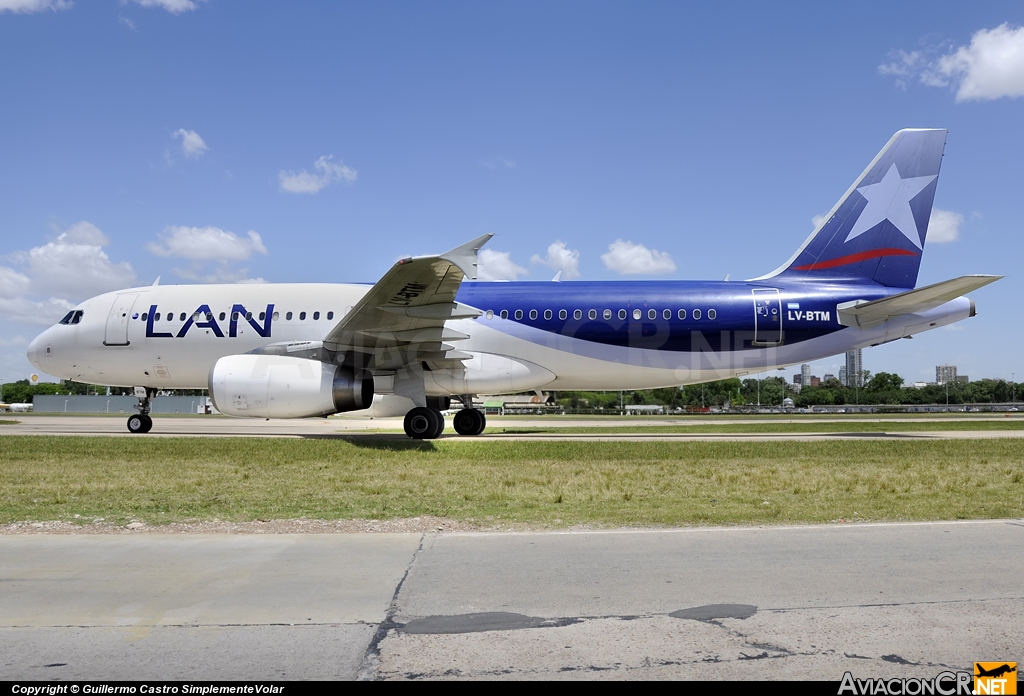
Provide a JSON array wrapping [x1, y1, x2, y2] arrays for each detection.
[[0, 414, 1024, 441]]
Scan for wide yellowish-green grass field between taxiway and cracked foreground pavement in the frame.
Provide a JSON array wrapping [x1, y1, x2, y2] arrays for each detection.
[[0, 436, 1024, 527]]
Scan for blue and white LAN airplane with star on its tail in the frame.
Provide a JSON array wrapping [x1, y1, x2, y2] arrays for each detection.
[[28, 129, 1001, 439]]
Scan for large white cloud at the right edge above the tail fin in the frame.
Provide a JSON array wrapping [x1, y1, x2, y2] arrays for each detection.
[[879, 24, 1024, 101]]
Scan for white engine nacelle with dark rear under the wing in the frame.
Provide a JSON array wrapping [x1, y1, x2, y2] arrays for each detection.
[[210, 353, 374, 418]]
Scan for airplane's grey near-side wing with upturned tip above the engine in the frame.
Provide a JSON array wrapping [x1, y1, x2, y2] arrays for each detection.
[[324, 234, 494, 368]]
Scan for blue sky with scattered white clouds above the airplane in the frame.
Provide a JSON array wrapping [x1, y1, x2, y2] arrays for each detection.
[[0, 0, 1024, 381]]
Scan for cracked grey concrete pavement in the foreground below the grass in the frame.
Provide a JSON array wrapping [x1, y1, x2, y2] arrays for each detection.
[[0, 520, 1024, 681]]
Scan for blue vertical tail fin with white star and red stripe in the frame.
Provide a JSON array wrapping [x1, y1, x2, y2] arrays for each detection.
[[755, 129, 946, 288]]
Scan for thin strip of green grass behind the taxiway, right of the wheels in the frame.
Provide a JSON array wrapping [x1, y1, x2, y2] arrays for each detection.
[[487, 419, 1024, 435]]
